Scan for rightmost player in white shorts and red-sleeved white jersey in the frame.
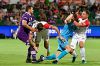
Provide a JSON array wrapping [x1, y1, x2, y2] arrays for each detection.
[[70, 10, 90, 64]]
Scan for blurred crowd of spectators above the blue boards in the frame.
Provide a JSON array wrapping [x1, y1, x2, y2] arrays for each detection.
[[0, 0, 100, 25]]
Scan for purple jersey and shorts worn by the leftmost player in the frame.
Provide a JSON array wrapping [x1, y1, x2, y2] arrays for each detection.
[[17, 12, 34, 43]]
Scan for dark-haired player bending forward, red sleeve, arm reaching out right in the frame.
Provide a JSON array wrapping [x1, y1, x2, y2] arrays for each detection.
[[33, 21, 60, 56]]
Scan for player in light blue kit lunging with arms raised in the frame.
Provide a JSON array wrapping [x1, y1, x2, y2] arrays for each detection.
[[38, 14, 74, 64]]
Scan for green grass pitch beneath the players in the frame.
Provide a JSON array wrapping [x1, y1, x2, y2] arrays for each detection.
[[0, 38, 100, 66]]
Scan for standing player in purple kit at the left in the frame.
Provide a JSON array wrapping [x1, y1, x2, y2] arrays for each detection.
[[17, 5, 37, 63]]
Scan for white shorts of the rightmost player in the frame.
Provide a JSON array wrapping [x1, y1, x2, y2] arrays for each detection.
[[70, 34, 86, 49]]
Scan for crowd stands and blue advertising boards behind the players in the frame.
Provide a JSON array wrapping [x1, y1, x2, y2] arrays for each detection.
[[0, 0, 100, 37]]
